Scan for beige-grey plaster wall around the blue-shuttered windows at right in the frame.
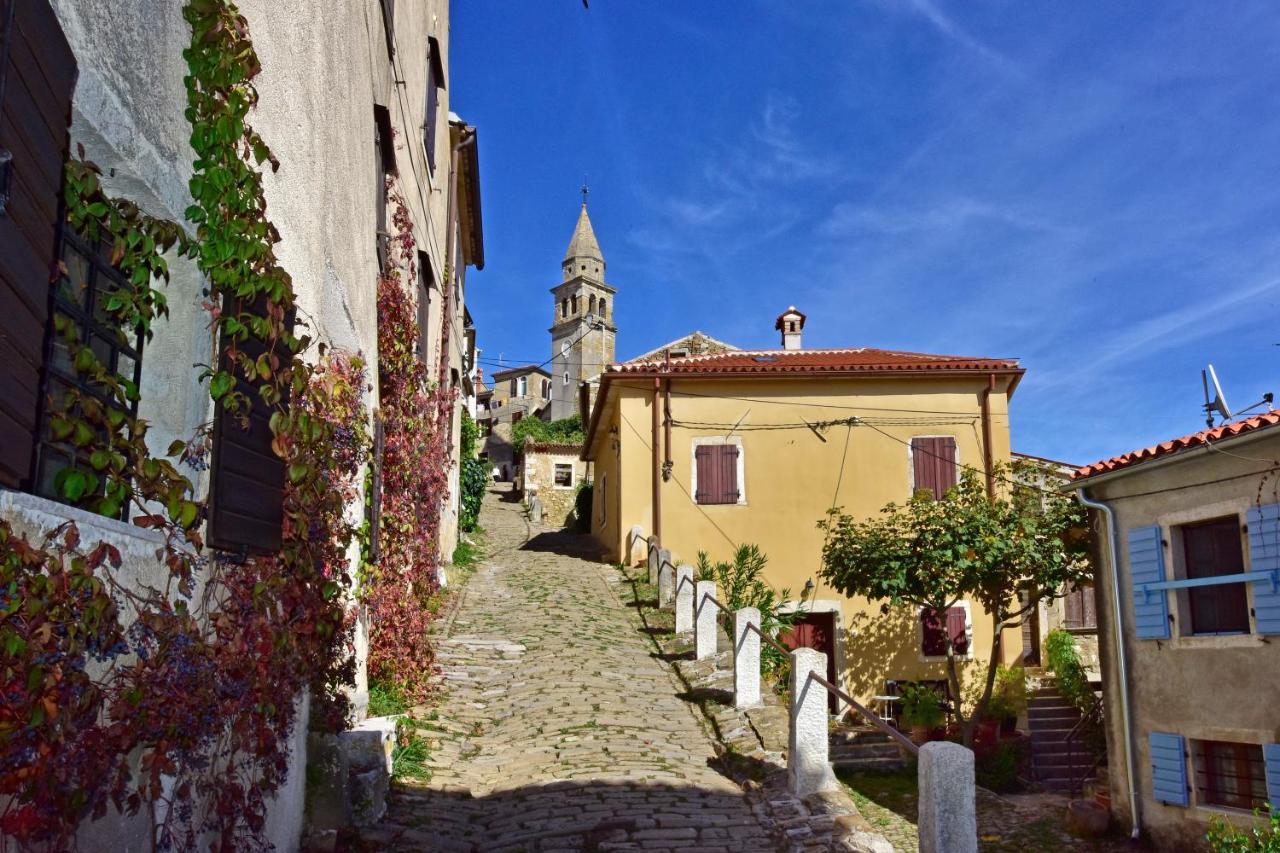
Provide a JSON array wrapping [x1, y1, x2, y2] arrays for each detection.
[[1088, 429, 1280, 848]]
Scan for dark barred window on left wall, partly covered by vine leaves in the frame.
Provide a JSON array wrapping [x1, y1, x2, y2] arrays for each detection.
[[33, 228, 142, 512]]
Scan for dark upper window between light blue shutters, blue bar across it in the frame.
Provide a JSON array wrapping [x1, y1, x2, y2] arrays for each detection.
[[1181, 517, 1249, 634]]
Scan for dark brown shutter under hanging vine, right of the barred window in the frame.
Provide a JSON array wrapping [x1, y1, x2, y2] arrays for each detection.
[[209, 302, 292, 553]]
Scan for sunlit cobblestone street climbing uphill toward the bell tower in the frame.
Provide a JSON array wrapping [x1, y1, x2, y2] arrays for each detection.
[[362, 493, 778, 853]]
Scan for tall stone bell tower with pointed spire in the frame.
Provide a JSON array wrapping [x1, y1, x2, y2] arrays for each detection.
[[549, 187, 618, 420]]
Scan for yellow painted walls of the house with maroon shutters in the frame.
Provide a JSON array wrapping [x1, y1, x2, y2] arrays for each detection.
[[586, 371, 1021, 699]]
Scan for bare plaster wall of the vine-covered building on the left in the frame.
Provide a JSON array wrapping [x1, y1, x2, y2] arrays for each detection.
[[0, 0, 465, 850]]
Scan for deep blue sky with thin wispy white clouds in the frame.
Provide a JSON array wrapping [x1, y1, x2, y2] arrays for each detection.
[[451, 0, 1280, 464]]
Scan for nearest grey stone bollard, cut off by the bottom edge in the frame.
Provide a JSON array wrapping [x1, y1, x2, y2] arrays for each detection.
[[919, 740, 978, 853]]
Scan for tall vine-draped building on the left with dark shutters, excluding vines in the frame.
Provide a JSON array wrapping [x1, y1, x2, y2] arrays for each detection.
[[0, 0, 484, 835]]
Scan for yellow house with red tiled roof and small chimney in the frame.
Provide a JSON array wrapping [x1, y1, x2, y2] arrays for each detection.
[[584, 307, 1023, 699]]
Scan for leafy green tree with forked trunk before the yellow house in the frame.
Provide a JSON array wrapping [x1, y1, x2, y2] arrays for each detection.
[[818, 465, 1092, 745]]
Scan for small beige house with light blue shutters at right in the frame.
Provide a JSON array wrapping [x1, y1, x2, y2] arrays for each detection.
[[1075, 416, 1280, 849]]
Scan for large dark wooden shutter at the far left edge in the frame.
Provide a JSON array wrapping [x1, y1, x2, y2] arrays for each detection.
[[0, 0, 76, 488]]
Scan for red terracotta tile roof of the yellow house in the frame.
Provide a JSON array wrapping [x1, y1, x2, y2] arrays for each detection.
[[605, 347, 1020, 375]]
